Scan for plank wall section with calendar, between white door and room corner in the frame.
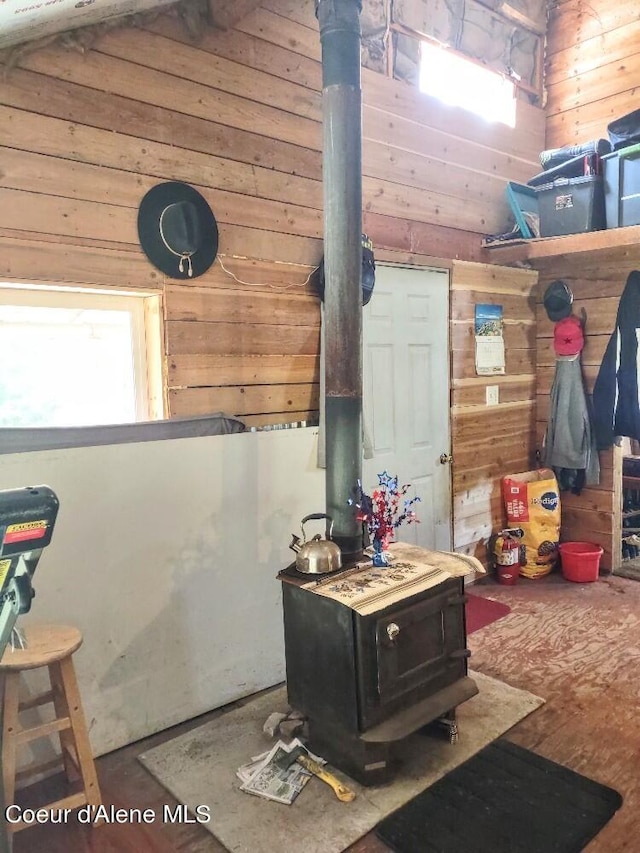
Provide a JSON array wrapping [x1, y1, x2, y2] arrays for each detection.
[[451, 261, 537, 561]]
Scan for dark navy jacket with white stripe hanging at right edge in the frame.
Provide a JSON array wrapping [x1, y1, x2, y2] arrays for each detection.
[[593, 270, 640, 450]]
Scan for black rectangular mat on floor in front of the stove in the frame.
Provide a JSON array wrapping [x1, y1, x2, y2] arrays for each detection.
[[376, 740, 622, 853]]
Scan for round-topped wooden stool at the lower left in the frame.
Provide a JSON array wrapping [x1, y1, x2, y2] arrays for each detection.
[[0, 625, 102, 832]]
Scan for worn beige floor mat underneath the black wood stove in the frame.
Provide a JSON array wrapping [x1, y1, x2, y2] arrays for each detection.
[[140, 672, 547, 853]]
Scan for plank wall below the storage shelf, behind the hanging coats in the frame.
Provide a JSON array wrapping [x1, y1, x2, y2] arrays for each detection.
[[536, 247, 640, 570]]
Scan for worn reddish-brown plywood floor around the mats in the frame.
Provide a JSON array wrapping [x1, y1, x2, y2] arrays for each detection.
[[14, 575, 640, 853]]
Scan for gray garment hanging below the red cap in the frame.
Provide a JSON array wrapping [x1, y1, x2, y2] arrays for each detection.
[[543, 356, 600, 494]]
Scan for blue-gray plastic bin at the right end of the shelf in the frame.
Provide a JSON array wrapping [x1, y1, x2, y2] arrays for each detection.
[[602, 144, 640, 228]]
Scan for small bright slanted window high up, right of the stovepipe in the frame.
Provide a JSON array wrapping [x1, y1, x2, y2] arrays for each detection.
[[420, 42, 516, 127]]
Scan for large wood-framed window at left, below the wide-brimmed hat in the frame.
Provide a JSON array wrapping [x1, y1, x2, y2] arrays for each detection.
[[0, 283, 163, 427]]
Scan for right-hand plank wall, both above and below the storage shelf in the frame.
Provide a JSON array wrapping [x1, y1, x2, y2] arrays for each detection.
[[536, 0, 640, 569]]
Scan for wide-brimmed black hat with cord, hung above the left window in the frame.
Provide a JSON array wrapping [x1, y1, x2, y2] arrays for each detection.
[[138, 181, 218, 278]]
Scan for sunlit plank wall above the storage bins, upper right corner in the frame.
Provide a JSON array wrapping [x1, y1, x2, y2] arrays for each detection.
[[545, 0, 640, 148]]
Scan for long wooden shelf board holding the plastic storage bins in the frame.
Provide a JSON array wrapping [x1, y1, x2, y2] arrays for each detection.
[[484, 225, 640, 266]]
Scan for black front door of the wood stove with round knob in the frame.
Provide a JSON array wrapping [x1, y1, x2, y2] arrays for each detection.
[[356, 578, 469, 731]]
